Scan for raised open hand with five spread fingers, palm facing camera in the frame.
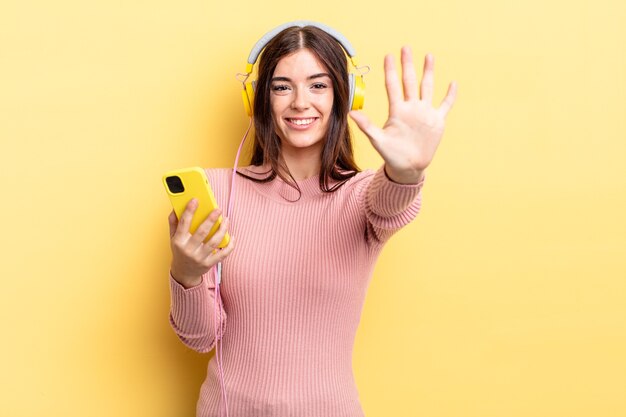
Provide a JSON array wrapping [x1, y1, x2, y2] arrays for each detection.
[[350, 46, 457, 184]]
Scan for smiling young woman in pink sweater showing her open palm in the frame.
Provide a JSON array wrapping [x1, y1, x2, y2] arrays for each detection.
[[169, 25, 456, 417]]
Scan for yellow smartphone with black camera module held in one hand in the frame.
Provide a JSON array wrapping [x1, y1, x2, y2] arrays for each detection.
[[163, 167, 230, 248]]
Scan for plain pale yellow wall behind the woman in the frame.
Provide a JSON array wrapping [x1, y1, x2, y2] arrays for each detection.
[[0, 0, 626, 417]]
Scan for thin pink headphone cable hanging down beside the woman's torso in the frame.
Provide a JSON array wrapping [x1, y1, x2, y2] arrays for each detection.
[[211, 118, 252, 417]]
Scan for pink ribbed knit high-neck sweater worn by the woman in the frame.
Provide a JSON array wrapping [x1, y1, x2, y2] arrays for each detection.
[[170, 167, 423, 417]]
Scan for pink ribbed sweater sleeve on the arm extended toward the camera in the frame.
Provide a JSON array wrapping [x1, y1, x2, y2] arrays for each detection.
[[359, 166, 424, 246]]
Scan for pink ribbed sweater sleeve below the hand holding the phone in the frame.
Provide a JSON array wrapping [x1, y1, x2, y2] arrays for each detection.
[[170, 269, 226, 353]]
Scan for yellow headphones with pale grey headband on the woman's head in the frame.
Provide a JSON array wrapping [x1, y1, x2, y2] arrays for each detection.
[[239, 20, 369, 117]]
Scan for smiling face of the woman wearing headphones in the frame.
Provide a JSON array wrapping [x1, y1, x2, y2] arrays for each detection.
[[270, 49, 333, 158]]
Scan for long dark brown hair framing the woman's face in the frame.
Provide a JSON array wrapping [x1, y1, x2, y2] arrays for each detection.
[[236, 26, 359, 197]]
